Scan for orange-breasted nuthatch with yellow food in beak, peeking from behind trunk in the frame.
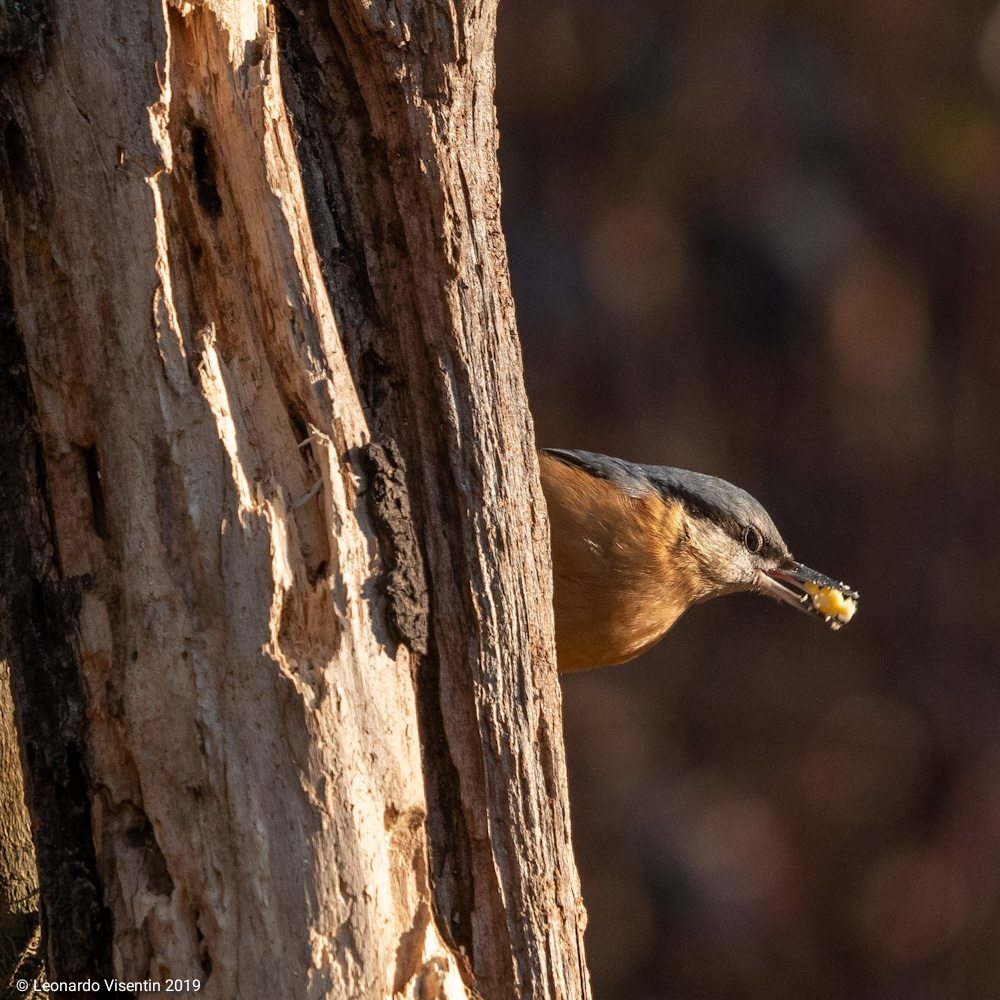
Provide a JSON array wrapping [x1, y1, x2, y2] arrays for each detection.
[[538, 449, 858, 671]]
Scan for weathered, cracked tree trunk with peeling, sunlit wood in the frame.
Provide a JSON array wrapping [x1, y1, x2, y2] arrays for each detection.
[[0, 0, 589, 1000]]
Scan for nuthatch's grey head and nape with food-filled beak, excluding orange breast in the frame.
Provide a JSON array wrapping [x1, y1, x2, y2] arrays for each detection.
[[550, 451, 858, 629]]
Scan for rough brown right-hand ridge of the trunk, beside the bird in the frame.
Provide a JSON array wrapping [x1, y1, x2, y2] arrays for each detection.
[[279, 3, 587, 996]]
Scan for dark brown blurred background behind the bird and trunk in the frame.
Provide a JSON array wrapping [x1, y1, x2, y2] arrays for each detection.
[[498, 0, 1000, 1000]]
